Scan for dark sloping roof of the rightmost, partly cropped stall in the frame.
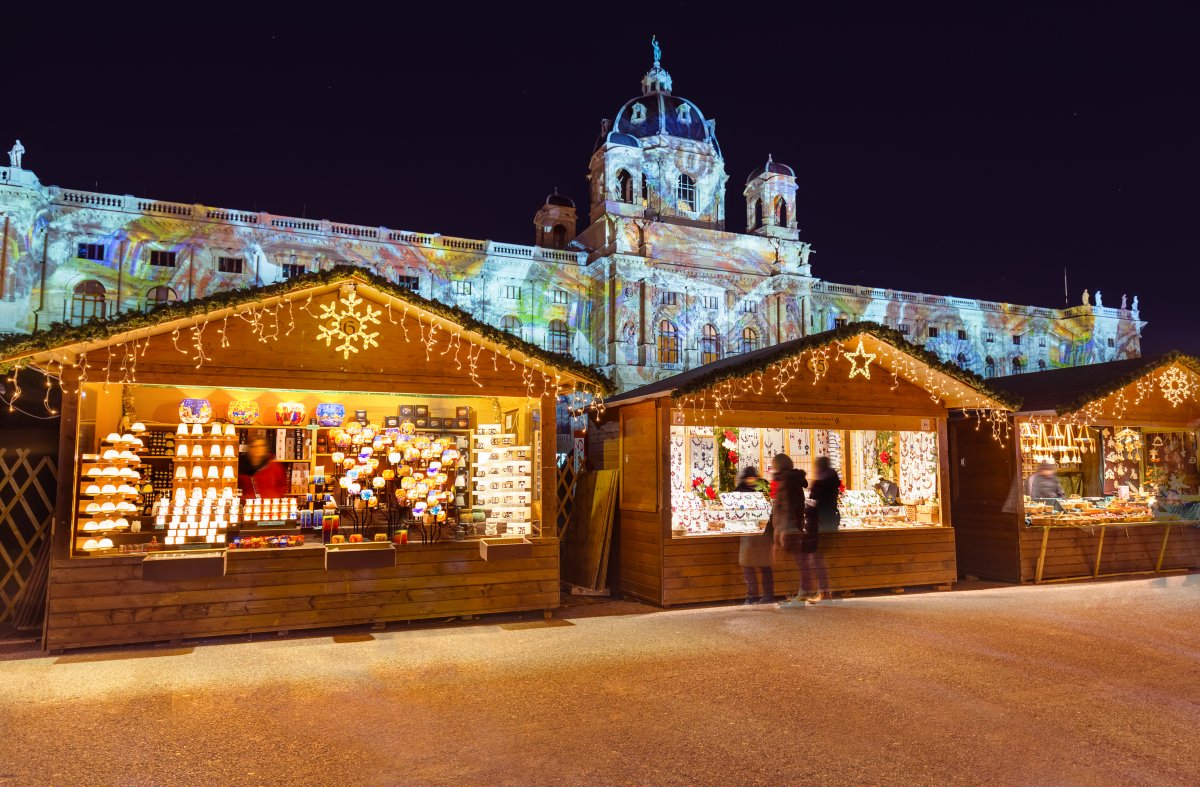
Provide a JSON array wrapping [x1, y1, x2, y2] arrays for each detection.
[[990, 350, 1200, 415]]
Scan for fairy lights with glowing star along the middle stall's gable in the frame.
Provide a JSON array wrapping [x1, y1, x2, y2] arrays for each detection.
[[676, 337, 1010, 444]]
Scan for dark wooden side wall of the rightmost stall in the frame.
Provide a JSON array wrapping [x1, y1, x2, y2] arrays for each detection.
[[949, 421, 1022, 582]]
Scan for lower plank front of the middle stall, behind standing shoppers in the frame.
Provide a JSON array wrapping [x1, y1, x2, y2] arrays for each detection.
[[662, 528, 958, 606]]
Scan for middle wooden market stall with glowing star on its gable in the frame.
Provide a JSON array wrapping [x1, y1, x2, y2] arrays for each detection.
[[589, 323, 1006, 606]]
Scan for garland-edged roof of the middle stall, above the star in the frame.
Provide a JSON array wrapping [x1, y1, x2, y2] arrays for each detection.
[[607, 322, 1020, 409]]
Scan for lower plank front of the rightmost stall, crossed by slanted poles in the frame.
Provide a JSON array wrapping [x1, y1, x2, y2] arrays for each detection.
[[1020, 525, 1200, 582]]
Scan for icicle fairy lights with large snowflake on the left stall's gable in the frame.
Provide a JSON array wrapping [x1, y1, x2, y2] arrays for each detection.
[[0, 283, 605, 419]]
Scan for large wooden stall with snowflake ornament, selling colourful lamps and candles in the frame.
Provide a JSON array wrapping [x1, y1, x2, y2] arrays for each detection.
[[0, 268, 607, 650]]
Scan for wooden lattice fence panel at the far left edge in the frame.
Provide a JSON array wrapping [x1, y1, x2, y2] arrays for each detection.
[[0, 447, 58, 621]]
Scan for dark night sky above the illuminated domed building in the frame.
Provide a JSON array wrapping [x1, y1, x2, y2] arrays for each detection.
[[9, 2, 1200, 354]]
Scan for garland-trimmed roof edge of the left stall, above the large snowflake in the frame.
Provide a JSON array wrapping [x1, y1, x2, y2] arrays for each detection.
[[0, 265, 613, 394]]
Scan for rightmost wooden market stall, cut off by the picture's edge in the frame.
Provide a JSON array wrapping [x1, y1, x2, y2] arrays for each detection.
[[950, 353, 1200, 582]]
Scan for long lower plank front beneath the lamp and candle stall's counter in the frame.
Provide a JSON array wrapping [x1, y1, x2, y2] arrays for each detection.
[[46, 539, 559, 650]]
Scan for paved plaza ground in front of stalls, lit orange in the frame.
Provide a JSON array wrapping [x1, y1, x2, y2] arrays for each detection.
[[0, 575, 1200, 786]]
